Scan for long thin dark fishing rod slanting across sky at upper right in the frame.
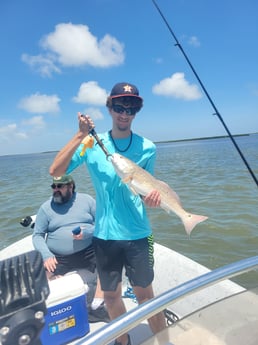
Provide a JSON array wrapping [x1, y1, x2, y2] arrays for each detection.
[[152, 0, 258, 187]]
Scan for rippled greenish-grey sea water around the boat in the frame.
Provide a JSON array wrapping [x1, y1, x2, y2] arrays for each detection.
[[0, 135, 258, 288]]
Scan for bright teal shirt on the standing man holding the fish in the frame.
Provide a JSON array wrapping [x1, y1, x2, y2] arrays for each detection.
[[67, 132, 156, 240]]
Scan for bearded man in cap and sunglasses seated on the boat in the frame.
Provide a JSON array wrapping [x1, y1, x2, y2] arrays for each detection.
[[32, 175, 109, 322]]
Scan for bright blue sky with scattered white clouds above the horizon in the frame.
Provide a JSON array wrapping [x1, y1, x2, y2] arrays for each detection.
[[0, 0, 258, 155]]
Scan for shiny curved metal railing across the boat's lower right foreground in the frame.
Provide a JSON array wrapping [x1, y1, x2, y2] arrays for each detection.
[[75, 256, 258, 345]]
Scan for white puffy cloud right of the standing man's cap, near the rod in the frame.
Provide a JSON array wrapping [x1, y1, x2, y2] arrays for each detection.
[[152, 73, 202, 100]]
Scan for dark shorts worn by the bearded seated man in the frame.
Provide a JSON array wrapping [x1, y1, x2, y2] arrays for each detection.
[[54, 245, 96, 275]]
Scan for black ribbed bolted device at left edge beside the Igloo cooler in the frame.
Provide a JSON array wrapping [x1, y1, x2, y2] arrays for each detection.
[[0, 250, 50, 345]]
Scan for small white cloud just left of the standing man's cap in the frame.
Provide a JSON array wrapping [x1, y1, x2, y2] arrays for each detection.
[[73, 81, 108, 106]]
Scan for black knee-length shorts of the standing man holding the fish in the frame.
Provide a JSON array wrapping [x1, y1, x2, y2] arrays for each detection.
[[92, 235, 154, 291]]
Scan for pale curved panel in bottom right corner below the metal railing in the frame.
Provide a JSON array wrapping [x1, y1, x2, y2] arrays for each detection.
[[142, 291, 258, 345]]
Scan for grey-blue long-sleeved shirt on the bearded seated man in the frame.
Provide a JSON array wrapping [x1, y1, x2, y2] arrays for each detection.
[[32, 193, 96, 260]]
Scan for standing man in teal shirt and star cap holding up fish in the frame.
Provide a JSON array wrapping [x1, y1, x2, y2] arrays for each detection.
[[49, 83, 165, 345]]
